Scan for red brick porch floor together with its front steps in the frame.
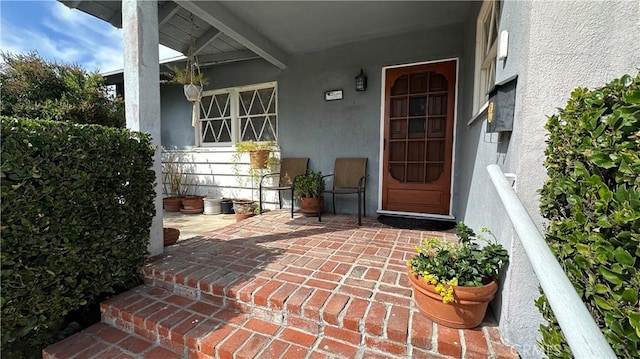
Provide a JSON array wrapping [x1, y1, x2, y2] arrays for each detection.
[[43, 211, 518, 358]]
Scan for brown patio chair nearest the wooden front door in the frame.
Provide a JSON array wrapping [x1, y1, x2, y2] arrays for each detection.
[[323, 157, 367, 226]]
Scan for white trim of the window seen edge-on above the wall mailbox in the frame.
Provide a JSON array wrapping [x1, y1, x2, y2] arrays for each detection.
[[467, 0, 500, 125]]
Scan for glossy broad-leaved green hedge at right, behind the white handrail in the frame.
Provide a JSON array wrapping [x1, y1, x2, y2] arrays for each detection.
[[537, 74, 640, 358]]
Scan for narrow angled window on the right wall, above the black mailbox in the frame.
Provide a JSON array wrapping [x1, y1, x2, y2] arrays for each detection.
[[473, 0, 501, 114]]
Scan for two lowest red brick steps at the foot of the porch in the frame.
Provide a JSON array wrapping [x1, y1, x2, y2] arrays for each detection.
[[43, 286, 400, 359]]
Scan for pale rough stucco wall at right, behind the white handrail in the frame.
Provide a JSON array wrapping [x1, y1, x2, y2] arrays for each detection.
[[458, 0, 640, 358]]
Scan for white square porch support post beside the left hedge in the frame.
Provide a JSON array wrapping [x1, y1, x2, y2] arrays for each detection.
[[122, 0, 164, 255]]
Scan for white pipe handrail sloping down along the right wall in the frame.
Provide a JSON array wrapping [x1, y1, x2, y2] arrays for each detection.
[[487, 164, 616, 359]]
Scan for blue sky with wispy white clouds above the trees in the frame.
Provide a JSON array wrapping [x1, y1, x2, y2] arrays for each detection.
[[0, 0, 180, 72]]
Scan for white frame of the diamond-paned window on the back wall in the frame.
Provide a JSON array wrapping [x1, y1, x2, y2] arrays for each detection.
[[194, 81, 280, 148]]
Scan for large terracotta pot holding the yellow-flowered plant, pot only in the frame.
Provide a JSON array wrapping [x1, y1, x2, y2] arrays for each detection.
[[409, 269, 498, 329]]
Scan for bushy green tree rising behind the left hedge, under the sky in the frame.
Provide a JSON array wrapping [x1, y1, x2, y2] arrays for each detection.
[[0, 52, 125, 127]]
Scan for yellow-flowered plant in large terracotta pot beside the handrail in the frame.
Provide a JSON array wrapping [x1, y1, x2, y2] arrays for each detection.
[[407, 222, 509, 328]]
